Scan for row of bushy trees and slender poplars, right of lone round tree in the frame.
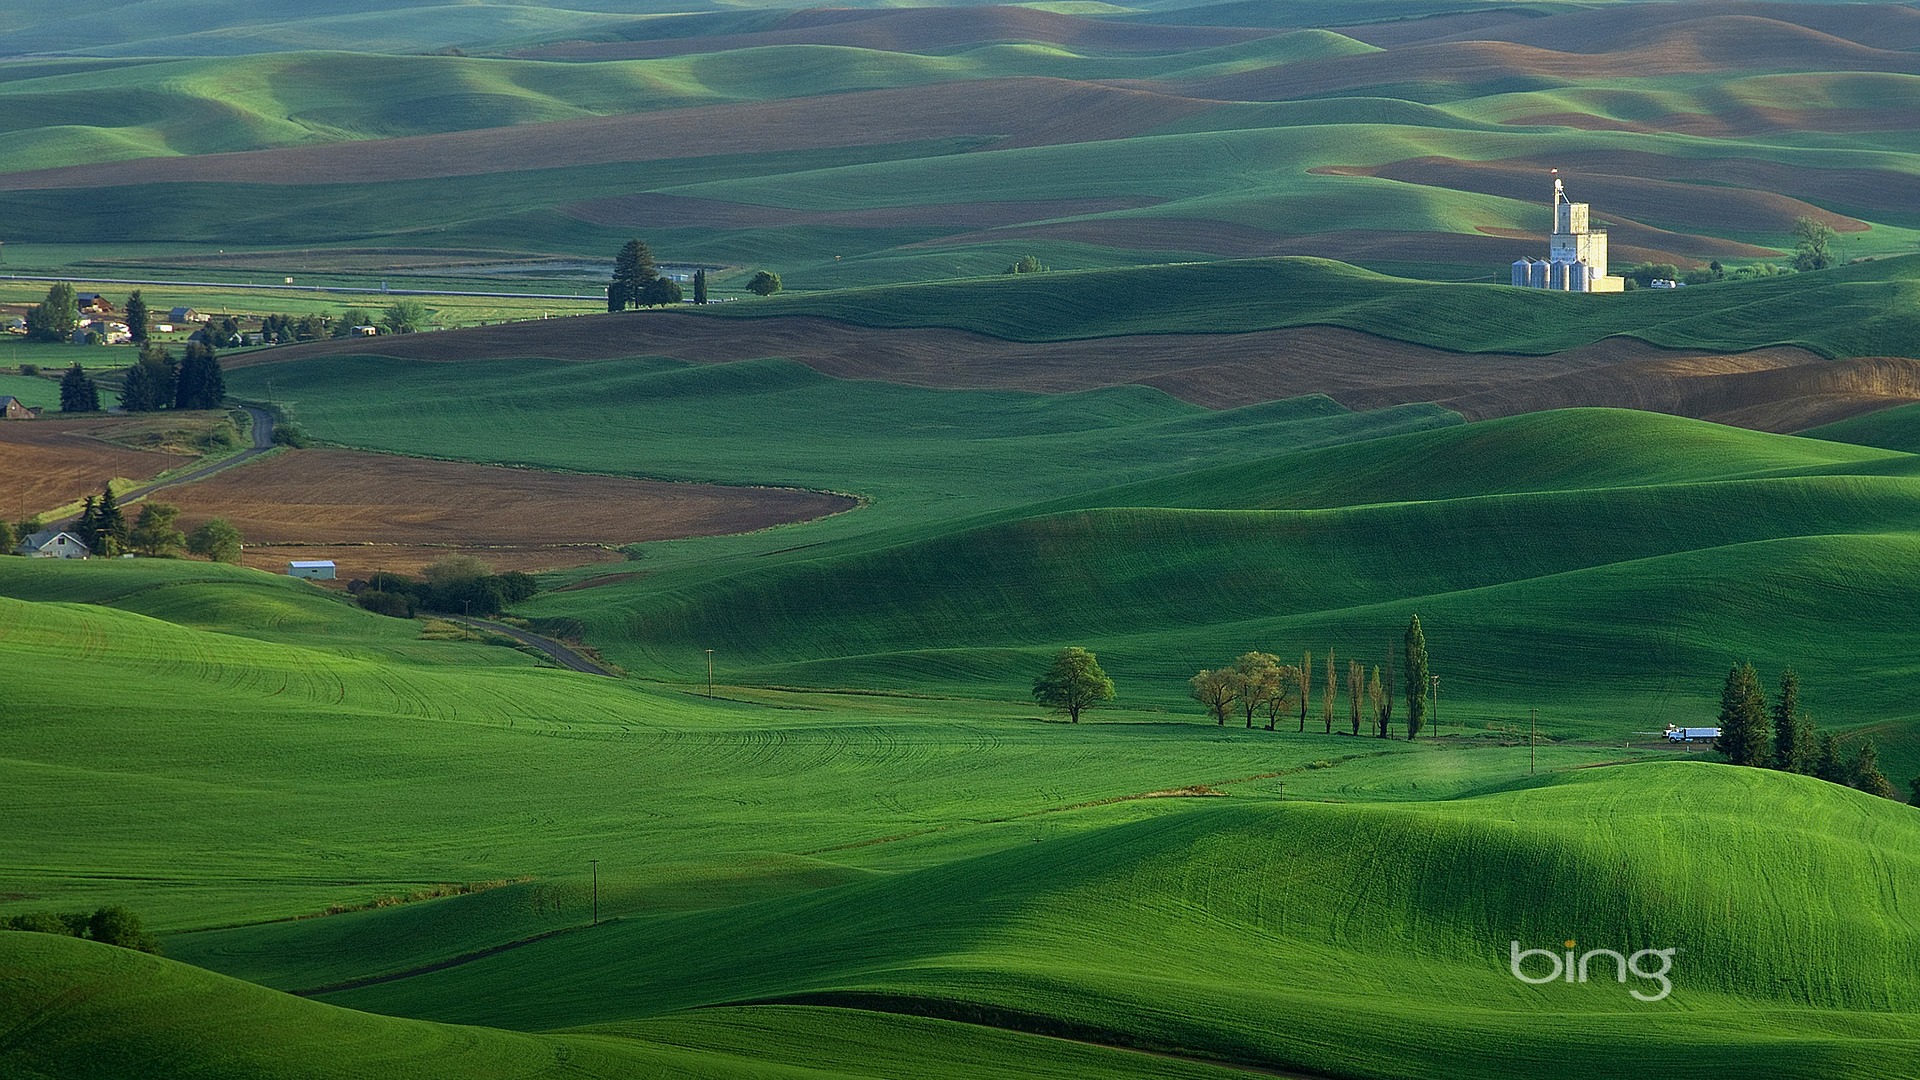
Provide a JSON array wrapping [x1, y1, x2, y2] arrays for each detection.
[[1190, 615, 1432, 738]]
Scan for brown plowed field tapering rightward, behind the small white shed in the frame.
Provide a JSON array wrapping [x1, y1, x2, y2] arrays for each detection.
[[156, 450, 854, 577]]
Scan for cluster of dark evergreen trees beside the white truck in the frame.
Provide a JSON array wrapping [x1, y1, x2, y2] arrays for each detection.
[[1713, 663, 1920, 805]]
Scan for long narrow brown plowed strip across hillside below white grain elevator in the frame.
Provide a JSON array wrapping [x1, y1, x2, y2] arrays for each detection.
[[238, 313, 1920, 430]]
